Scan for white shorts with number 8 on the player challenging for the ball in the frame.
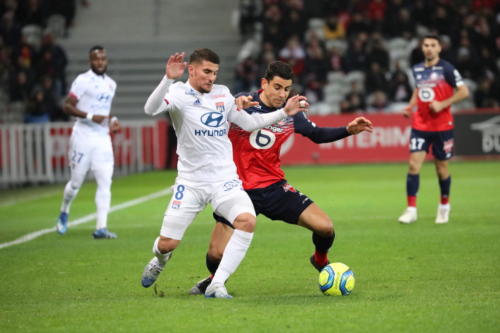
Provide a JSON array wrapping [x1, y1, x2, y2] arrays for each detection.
[[160, 178, 255, 240]]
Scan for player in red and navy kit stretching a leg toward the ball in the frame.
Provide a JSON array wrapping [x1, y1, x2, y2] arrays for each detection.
[[191, 61, 372, 294]]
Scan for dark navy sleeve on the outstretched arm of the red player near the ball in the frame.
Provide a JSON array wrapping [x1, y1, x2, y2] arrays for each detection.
[[293, 112, 350, 143]]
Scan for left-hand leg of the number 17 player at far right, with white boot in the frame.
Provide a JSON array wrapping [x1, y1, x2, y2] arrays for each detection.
[[398, 151, 427, 224]]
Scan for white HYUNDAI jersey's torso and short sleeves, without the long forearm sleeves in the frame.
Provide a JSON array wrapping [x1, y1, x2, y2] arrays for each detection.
[[163, 82, 238, 182]]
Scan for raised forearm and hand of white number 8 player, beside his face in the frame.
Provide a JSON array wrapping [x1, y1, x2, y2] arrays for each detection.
[[144, 52, 187, 116]]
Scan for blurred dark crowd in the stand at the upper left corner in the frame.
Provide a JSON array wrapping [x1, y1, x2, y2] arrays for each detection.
[[0, 0, 87, 123]]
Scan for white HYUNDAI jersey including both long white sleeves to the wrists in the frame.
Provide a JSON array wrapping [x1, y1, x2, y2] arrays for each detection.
[[144, 77, 286, 185]]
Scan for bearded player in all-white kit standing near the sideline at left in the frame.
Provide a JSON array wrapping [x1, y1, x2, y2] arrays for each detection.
[[56, 46, 120, 239]]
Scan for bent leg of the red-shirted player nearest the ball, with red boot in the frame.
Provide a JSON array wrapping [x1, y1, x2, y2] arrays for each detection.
[[297, 203, 335, 271]]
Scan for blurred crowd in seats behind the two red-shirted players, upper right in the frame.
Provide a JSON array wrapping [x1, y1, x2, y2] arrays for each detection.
[[235, 0, 500, 113]]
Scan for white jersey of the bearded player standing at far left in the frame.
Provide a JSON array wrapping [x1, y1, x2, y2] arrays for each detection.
[[69, 69, 116, 135]]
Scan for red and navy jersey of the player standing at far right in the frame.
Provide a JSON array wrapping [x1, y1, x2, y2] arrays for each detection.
[[412, 59, 464, 131]]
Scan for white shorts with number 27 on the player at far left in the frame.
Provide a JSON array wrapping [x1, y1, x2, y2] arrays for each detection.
[[68, 135, 114, 176]]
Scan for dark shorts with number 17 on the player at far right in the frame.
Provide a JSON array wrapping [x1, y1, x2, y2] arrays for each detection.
[[410, 128, 453, 161]]
